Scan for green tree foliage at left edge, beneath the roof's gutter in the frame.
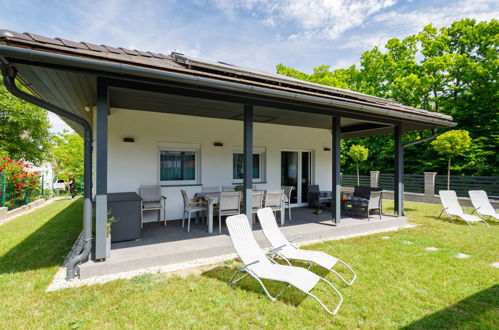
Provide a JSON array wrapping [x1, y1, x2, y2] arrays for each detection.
[[0, 76, 50, 165]]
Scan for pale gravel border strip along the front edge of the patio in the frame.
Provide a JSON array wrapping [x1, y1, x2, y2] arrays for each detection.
[[46, 224, 418, 292]]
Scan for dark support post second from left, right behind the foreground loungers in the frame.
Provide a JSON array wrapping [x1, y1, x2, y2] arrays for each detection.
[[243, 104, 253, 226]]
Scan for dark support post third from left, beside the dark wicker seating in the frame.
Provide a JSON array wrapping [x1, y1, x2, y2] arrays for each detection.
[[331, 116, 341, 224]]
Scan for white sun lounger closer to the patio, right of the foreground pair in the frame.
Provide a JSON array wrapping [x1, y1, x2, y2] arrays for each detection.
[[257, 208, 357, 285]]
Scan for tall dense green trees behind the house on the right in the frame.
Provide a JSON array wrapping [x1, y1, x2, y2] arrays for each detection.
[[277, 19, 499, 175]]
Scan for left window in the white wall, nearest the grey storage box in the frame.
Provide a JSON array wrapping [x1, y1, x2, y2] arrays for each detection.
[[159, 151, 198, 184]]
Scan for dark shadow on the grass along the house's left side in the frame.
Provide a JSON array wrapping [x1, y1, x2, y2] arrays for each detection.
[[0, 200, 83, 274]]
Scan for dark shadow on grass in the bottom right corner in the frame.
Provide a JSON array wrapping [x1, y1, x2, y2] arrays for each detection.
[[402, 285, 499, 330]]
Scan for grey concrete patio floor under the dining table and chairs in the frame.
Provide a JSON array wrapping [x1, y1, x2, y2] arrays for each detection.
[[80, 207, 407, 279]]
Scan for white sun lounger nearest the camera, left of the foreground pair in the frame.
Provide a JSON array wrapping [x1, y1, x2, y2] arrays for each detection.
[[226, 214, 343, 315]]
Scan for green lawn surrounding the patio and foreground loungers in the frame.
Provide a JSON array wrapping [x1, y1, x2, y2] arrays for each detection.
[[0, 200, 499, 329]]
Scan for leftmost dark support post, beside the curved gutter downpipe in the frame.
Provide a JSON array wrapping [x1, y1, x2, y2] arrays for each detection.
[[95, 80, 109, 259]]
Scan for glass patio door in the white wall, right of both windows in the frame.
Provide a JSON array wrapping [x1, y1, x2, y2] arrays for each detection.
[[281, 151, 312, 205]]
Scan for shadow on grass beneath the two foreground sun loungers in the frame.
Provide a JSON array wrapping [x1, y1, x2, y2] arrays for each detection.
[[202, 264, 336, 307]]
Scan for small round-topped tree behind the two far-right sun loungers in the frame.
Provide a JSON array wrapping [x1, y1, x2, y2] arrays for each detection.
[[431, 130, 471, 190]]
